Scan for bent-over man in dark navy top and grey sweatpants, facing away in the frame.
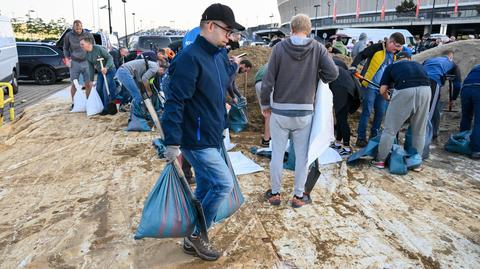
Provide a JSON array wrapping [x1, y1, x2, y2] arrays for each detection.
[[372, 51, 431, 171]]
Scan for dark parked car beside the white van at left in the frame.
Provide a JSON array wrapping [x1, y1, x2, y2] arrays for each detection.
[[17, 42, 70, 85]]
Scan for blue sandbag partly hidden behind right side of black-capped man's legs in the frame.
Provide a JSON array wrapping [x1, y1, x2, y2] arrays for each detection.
[[213, 143, 245, 222]]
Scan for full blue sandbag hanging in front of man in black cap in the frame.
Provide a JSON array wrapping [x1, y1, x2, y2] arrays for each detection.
[[134, 163, 198, 239]]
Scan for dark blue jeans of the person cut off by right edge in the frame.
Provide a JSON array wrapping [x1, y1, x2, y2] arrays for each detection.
[[460, 86, 480, 152]]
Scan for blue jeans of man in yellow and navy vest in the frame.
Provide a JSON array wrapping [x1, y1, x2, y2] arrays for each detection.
[[358, 88, 388, 140]]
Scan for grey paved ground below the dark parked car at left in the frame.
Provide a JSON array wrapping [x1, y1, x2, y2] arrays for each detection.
[[3, 79, 70, 122]]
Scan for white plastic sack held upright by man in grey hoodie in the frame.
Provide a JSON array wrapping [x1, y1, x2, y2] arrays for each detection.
[[308, 80, 335, 165]]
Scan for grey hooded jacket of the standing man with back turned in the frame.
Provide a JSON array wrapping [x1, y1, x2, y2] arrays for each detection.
[[260, 38, 338, 111]]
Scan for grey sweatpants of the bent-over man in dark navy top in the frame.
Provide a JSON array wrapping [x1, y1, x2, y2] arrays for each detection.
[[377, 86, 432, 161]]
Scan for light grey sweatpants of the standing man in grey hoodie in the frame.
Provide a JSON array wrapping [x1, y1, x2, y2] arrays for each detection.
[[270, 113, 313, 197]]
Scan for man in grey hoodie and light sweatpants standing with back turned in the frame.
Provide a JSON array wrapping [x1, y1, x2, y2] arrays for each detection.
[[261, 14, 338, 208]]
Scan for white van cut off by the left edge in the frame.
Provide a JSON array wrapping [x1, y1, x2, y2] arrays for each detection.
[[0, 16, 20, 93]]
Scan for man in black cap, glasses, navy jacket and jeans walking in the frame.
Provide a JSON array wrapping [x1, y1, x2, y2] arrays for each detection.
[[162, 4, 245, 260]]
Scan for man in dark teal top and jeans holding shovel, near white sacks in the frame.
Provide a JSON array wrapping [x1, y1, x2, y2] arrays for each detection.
[[80, 37, 117, 111]]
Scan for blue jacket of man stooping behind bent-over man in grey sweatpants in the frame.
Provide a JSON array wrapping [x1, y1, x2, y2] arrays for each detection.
[[423, 56, 462, 91]]
